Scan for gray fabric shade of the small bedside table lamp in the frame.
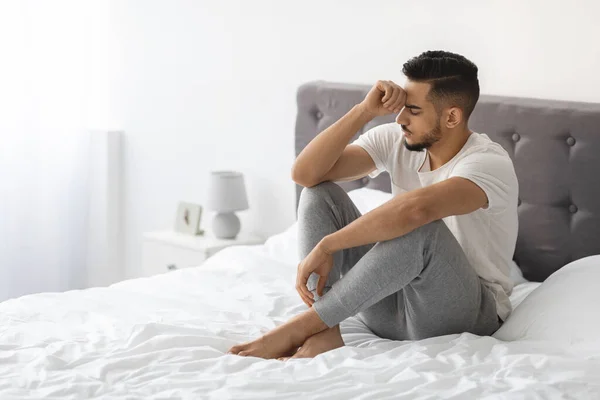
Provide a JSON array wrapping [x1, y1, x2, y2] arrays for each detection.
[[205, 171, 248, 213]]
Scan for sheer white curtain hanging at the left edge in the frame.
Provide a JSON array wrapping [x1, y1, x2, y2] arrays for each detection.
[[0, 0, 102, 301]]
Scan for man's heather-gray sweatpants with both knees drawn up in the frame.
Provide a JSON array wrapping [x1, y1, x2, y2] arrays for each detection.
[[298, 182, 501, 340]]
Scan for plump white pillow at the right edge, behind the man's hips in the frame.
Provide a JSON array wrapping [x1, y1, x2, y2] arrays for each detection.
[[493, 255, 600, 345]]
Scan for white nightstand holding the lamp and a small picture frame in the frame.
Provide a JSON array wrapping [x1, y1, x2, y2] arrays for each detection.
[[142, 231, 265, 276]]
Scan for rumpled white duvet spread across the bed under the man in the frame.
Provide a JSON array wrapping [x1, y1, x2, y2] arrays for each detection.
[[0, 223, 600, 400]]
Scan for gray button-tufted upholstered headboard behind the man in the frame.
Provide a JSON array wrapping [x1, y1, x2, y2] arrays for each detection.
[[295, 81, 600, 281]]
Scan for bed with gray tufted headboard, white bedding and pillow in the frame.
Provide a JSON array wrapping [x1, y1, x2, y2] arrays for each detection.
[[0, 81, 600, 400]]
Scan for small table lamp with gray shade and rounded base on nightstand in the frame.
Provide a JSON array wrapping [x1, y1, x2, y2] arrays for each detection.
[[205, 171, 248, 239]]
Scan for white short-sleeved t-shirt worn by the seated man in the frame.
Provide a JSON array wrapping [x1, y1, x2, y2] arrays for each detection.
[[351, 122, 519, 321]]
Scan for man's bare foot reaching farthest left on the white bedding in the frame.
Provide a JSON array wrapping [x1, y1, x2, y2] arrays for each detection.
[[227, 323, 308, 359]]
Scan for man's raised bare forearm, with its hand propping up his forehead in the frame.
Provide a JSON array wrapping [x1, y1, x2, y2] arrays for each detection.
[[292, 104, 373, 181]]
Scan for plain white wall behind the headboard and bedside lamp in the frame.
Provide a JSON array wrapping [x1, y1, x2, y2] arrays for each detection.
[[111, 0, 600, 276]]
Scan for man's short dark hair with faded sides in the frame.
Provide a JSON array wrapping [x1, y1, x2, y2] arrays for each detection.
[[402, 50, 479, 120]]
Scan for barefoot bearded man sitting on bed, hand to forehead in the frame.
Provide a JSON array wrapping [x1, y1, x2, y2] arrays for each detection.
[[229, 51, 518, 360]]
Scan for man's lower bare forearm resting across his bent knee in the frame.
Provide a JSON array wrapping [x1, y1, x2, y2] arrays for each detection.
[[319, 192, 431, 253]]
